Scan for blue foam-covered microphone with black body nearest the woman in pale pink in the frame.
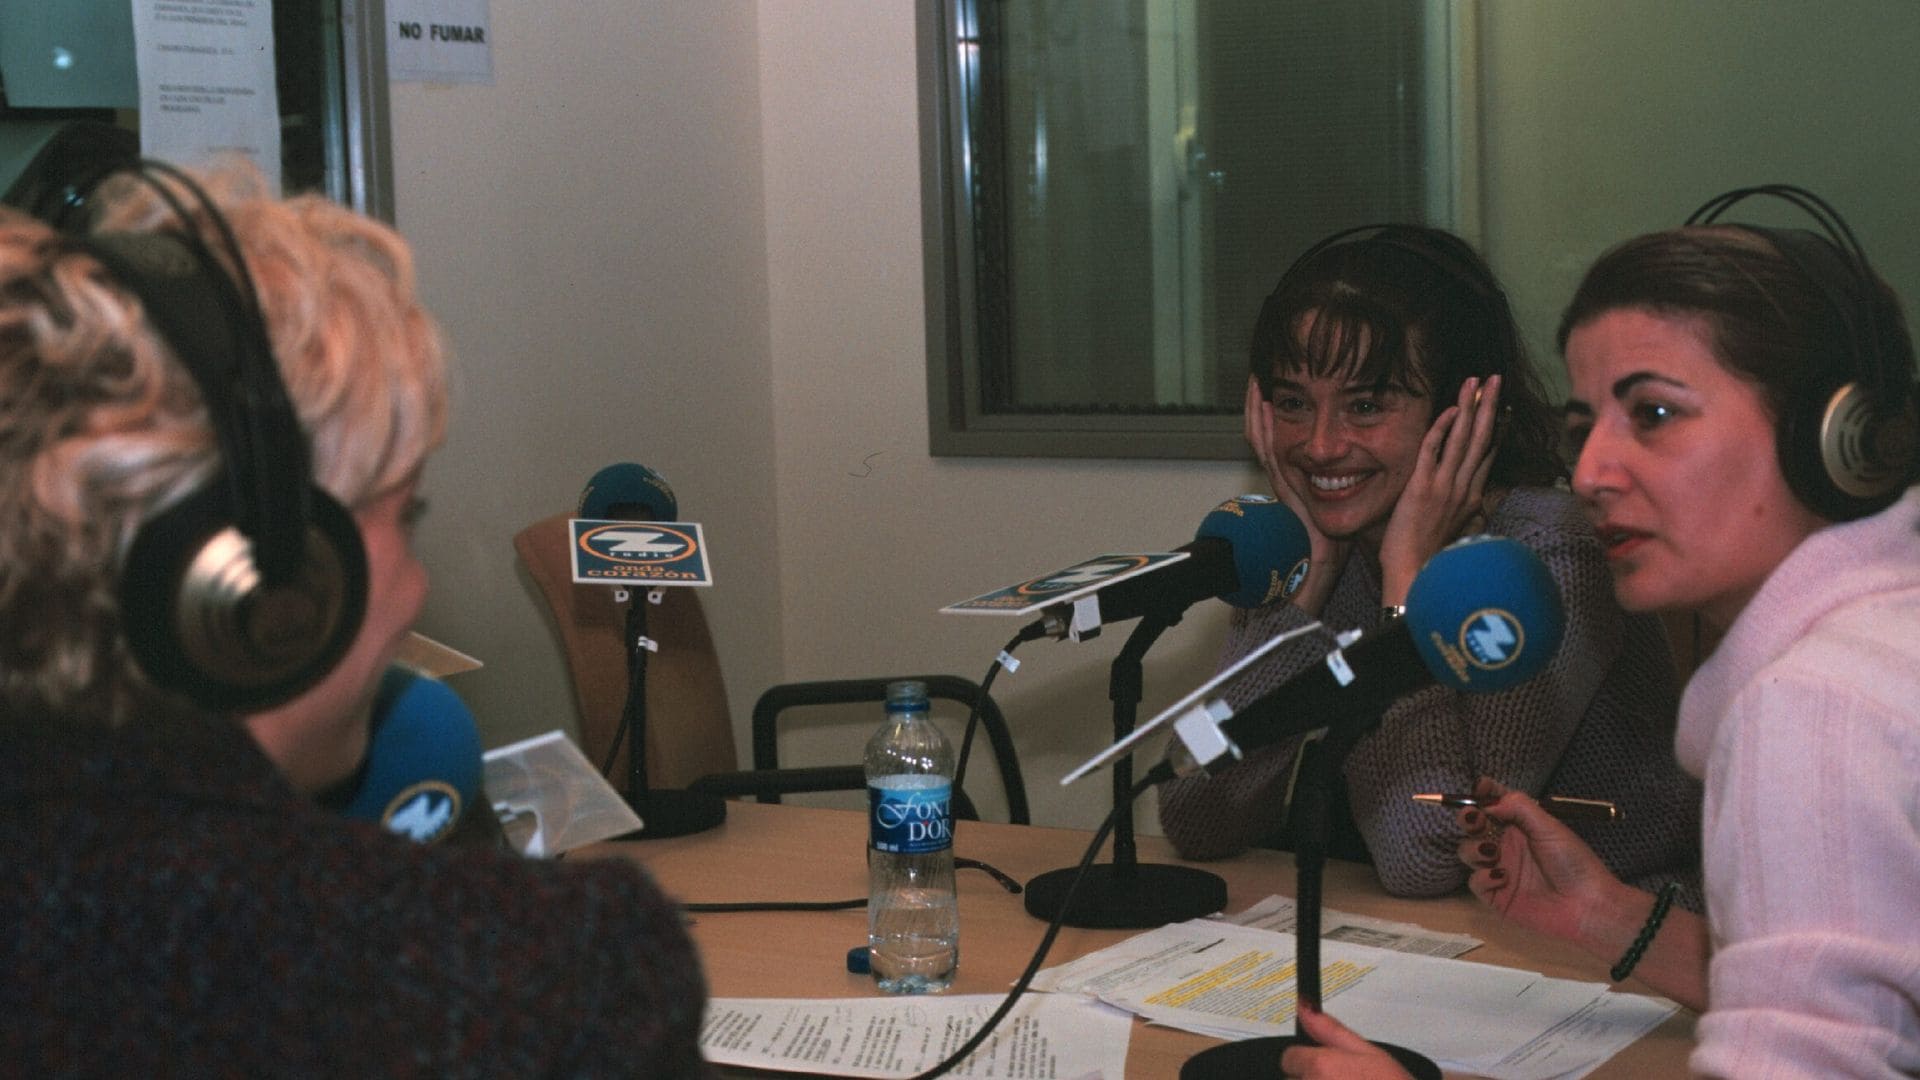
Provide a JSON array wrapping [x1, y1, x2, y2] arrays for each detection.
[[1164, 536, 1567, 776]]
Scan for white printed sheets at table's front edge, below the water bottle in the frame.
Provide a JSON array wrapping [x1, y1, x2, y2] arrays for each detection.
[[701, 994, 1133, 1080]]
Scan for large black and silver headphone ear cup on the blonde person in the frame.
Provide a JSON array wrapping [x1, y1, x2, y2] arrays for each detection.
[[121, 479, 367, 711]]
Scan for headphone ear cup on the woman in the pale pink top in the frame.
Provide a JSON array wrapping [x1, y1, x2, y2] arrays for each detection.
[[1778, 382, 1920, 521]]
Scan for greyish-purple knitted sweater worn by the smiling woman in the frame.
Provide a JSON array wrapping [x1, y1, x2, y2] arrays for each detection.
[[1160, 488, 1701, 911]]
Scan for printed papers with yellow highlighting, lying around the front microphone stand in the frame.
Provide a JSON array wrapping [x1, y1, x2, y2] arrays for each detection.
[[1033, 917, 1674, 1080]]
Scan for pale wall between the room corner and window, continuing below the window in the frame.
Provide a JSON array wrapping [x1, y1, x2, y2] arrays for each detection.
[[760, 0, 1254, 830]]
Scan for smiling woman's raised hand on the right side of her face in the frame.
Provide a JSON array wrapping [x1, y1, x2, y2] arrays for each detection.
[[1380, 375, 1500, 603]]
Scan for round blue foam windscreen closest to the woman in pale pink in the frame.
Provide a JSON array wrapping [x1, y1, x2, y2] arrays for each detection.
[[1405, 536, 1567, 694]]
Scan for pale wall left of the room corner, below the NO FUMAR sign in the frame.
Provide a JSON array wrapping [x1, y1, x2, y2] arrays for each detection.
[[392, 0, 781, 764]]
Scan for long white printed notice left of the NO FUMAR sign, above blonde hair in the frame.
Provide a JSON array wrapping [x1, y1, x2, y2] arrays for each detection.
[[132, 0, 280, 192]]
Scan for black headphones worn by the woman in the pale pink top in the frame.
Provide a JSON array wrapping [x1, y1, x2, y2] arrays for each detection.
[[1686, 184, 1920, 521]]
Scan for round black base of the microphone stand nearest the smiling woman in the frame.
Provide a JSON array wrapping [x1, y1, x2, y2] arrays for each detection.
[[1025, 863, 1227, 930]]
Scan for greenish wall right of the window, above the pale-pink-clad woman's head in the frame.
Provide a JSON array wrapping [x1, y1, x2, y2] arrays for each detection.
[[1480, 0, 1920, 399]]
